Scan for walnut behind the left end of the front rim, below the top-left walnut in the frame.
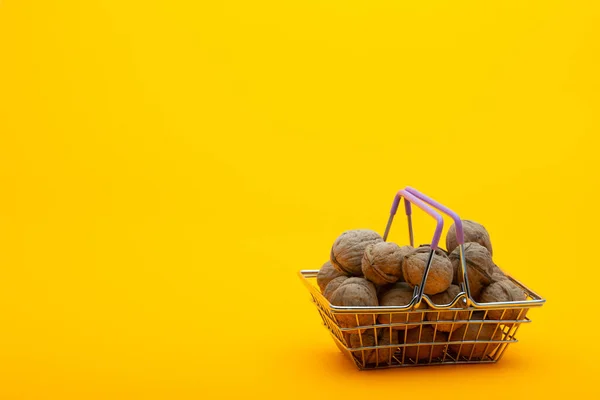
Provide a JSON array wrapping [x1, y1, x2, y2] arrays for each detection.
[[329, 278, 379, 333]]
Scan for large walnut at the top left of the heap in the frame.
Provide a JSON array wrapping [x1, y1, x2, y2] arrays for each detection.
[[330, 229, 383, 276]]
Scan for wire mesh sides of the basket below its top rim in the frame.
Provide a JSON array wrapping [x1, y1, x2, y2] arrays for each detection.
[[300, 274, 531, 369]]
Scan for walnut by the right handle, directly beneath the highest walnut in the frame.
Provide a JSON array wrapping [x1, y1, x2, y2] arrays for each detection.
[[450, 242, 496, 300]]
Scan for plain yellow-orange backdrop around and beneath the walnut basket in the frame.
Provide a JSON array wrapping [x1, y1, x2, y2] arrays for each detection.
[[0, 0, 600, 399]]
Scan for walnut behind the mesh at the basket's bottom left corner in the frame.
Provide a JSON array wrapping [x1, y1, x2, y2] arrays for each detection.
[[349, 328, 398, 365]]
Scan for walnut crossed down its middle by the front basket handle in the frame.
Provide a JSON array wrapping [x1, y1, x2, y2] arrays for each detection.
[[402, 246, 453, 294]]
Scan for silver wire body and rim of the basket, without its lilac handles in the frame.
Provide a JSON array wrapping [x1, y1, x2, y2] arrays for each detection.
[[299, 270, 544, 369]]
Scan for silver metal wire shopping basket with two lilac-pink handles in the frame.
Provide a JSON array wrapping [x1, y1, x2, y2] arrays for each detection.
[[299, 187, 545, 369]]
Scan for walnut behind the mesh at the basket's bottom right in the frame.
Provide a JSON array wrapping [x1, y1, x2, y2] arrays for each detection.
[[449, 324, 502, 358]]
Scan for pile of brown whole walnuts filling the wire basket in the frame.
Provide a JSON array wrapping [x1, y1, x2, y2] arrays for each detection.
[[317, 220, 526, 362]]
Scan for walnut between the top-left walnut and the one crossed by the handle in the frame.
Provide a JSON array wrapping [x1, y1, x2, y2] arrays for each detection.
[[361, 242, 406, 286]]
